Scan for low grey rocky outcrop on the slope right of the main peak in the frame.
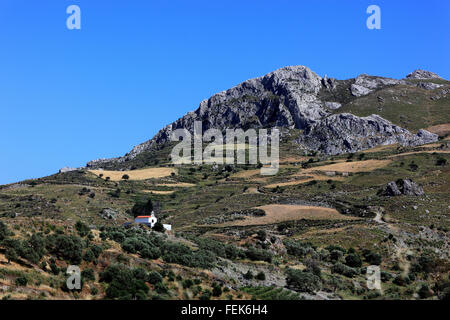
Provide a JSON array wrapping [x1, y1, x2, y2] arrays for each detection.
[[298, 113, 438, 155]]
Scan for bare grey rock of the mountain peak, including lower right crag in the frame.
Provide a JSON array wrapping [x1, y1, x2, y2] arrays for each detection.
[[88, 66, 439, 167]]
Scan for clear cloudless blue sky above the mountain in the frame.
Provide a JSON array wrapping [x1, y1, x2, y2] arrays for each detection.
[[0, 0, 450, 184]]
